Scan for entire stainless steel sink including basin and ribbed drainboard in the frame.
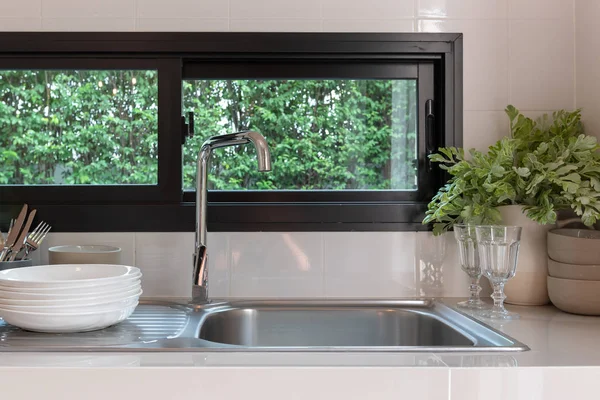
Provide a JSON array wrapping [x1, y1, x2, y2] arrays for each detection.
[[0, 300, 528, 352]]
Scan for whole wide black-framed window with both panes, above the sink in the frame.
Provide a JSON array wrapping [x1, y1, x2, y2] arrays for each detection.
[[0, 33, 462, 231]]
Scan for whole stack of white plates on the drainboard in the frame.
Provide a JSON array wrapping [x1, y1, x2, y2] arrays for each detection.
[[0, 264, 142, 333]]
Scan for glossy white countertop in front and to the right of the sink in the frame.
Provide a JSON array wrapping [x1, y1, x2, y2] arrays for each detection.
[[0, 299, 600, 400]]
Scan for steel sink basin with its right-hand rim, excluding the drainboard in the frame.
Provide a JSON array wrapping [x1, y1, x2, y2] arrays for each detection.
[[198, 300, 528, 351]]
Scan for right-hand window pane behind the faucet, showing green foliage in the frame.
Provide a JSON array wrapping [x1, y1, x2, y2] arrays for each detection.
[[183, 79, 418, 191]]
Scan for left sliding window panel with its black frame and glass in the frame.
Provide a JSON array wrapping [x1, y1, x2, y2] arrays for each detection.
[[0, 58, 181, 204]]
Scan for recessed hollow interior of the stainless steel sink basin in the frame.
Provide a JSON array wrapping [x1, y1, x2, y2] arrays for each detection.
[[200, 307, 475, 347]]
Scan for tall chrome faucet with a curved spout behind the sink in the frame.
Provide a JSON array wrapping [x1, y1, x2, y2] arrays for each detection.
[[192, 131, 271, 303]]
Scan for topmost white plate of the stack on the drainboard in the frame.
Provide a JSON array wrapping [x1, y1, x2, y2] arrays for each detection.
[[0, 264, 141, 288]]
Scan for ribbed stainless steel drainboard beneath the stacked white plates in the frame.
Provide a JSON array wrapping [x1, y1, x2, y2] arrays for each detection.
[[0, 304, 189, 350]]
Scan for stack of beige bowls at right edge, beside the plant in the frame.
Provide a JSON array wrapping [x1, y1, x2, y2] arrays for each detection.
[[548, 228, 600, 315]]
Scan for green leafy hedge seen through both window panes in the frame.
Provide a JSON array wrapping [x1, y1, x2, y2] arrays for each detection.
[[0, 71, 417, 190]]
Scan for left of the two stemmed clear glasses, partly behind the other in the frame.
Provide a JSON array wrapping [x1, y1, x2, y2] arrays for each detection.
[[454, 224, 486, 310]]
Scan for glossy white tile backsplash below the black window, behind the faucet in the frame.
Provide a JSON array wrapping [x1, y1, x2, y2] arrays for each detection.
[[34, 232, 474, 299]]
